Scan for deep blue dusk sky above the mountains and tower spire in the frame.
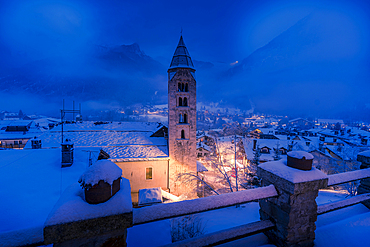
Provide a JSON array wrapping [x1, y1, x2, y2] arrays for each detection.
[[0, 0, 370, 117]]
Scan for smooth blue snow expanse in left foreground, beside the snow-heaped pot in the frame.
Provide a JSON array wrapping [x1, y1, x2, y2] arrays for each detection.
[[0, 148, 98, 246]]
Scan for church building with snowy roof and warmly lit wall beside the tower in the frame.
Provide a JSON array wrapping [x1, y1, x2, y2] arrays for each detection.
[[25, 121, 169, 202]]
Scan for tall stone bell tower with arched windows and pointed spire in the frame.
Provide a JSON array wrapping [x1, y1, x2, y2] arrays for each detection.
[[167, 36, 197, 195]]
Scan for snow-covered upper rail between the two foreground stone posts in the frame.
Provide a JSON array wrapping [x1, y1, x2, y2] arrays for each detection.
[[133, 185, 278, 225]]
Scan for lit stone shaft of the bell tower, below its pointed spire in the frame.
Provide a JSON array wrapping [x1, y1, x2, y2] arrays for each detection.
[[168, 68, 196, 195]]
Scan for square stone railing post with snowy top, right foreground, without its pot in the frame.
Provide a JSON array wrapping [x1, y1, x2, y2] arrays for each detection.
[[257, 160, 328, 246]]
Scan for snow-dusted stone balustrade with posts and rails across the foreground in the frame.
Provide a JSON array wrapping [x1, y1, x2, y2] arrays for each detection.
[[44, 154, 370, 247]]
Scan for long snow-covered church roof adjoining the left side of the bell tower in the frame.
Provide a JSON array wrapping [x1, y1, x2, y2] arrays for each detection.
[[26, 122, 168, 161]]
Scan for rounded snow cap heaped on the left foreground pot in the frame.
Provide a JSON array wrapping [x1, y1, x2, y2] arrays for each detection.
[[78, 160, 122, 186]]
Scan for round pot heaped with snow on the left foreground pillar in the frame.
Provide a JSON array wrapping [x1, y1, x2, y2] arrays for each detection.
[[78, 160, 122, 204]]
